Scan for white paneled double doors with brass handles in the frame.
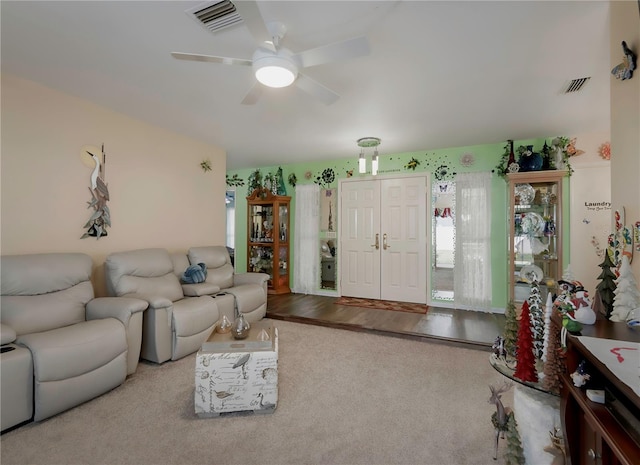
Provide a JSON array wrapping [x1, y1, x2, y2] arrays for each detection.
[[339, 176, 429, 303]]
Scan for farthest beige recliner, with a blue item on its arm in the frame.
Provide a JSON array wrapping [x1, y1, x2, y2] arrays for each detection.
[[171, 246, 269, 323]]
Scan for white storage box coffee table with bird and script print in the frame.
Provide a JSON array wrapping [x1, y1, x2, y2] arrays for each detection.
[[195, 323, 278, 418]]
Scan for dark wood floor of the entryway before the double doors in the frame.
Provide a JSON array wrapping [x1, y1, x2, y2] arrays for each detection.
[[267, 294, 504, 349]]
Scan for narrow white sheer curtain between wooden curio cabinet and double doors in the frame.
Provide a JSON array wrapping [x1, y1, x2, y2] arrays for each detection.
[[292, 184, 320, 294]]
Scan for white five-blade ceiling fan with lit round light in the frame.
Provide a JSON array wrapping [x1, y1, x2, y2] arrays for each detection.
[[171, 1, 369, 105]]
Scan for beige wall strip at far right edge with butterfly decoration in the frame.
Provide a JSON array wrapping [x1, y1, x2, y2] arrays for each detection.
[[610, 0, 640, 281]]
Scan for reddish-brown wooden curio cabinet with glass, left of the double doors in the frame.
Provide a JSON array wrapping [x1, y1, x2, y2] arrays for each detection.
[[247, 188, 291, 294]]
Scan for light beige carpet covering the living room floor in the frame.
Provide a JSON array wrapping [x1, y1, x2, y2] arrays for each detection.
[[0, 321, 516, 465]]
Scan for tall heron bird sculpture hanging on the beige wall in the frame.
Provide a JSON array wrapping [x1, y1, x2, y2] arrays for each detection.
[[81, 144, 111, 239]]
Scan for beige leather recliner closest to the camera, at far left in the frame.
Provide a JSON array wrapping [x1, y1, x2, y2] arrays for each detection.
[[0, 253, 147, 430]]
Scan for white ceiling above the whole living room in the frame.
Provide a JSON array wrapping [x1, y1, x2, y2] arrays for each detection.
[[0, 0, 608, 169]]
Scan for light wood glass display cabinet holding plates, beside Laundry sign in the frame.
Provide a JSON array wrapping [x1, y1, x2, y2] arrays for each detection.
[[506, 170, 567, 303]]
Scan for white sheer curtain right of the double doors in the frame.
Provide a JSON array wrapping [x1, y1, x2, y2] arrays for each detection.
[[454, 172, 491, 311]]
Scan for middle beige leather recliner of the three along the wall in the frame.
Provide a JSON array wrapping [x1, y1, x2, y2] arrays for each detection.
[[104, 248, 220, 363]]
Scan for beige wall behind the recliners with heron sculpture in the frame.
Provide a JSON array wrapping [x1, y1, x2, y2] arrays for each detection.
[[0, 74, 226, 295]]
